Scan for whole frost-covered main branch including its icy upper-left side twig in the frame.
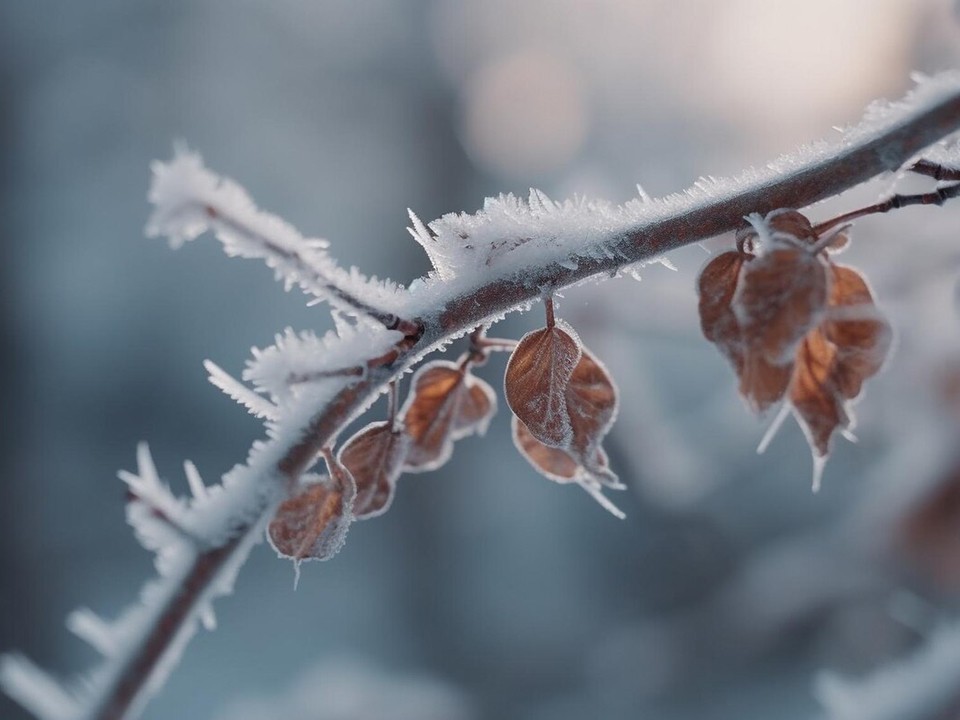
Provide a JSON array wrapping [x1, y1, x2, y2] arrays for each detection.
[[0, 71, 960, 720]]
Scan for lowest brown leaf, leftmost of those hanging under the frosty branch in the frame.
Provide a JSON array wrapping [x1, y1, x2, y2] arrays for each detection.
[[267, 478, 355, 563]]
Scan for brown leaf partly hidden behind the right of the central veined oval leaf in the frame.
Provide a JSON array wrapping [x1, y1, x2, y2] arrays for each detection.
[[566, 348, 618, 482]]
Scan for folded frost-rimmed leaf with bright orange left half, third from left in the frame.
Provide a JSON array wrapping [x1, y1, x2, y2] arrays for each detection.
[[403, 360, 496, 472]]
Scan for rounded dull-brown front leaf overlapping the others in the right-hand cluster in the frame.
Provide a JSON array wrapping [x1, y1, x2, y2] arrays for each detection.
[[733, 247, 828, 365]]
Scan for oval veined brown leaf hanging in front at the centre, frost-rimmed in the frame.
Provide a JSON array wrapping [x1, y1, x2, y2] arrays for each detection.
[[503, 322, 581, 447]]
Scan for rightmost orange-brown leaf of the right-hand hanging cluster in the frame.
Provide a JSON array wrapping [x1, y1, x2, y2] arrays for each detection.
[[823, 265, 893, 399]]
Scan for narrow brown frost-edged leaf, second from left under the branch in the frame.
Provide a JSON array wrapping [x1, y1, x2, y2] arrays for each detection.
[[338, 422, 410, 520]]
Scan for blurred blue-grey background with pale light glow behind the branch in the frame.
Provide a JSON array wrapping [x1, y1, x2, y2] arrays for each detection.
[[0, 0, 960, 720]]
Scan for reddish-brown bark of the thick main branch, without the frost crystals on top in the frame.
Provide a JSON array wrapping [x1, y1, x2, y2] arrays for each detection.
[[15, 79, 960, 720]]
